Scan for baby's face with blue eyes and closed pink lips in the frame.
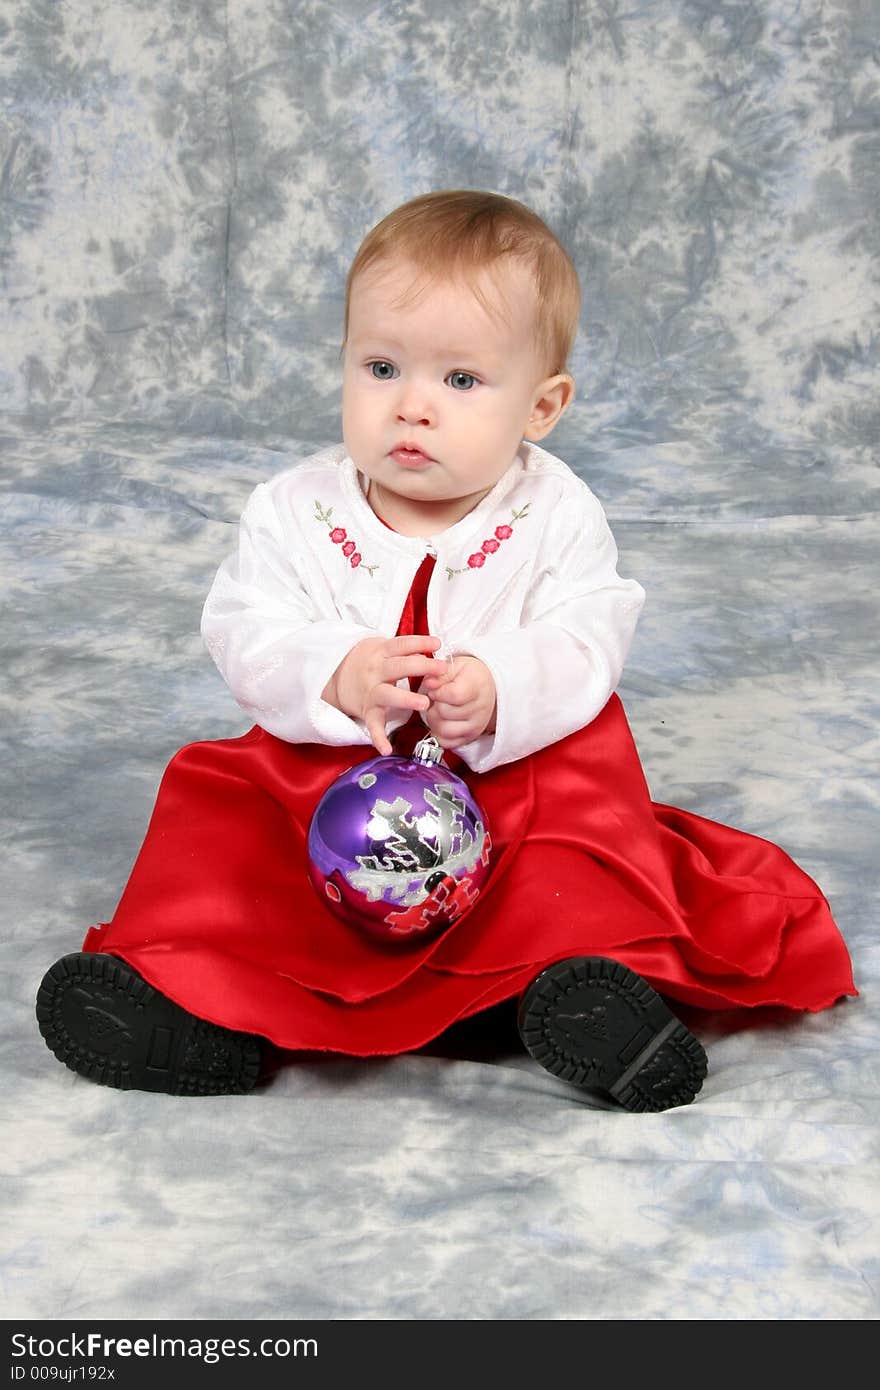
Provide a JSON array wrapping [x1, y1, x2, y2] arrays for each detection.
[[342, 261, 558, 520]]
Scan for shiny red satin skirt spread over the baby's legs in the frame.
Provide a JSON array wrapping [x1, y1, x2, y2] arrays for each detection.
[[83, 695, 856, 1056]]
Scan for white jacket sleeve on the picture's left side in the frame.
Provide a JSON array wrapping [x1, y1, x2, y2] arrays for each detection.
[[202, 482, 377, 745]]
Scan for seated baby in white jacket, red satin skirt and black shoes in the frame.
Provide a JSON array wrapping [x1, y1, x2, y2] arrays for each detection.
[[38, 190, 856, 1111]]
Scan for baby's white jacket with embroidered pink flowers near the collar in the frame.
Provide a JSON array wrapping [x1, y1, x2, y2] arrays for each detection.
[[202, 441, 645, 773]]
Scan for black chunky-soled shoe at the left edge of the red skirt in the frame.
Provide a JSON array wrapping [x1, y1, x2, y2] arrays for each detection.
[[36, 951, 260, 1095]]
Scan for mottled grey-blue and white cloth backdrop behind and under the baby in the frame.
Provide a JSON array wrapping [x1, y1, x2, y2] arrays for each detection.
[[0, 0, 880, 1319]]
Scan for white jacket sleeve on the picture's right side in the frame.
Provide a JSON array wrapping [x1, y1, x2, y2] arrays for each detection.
[[456, 492, 645, 771]]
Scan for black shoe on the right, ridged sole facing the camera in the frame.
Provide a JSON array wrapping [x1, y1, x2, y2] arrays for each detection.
[[517, 956, 706, 1111]]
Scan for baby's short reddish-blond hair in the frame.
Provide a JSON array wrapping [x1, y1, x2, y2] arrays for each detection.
[[341, 189, 581, 375]]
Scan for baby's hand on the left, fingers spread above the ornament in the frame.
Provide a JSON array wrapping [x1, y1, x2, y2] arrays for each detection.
[[323, 635, 445, 756]]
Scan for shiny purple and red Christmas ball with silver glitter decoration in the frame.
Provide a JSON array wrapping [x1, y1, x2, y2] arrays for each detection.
[[309, 734, 492, 942]]
